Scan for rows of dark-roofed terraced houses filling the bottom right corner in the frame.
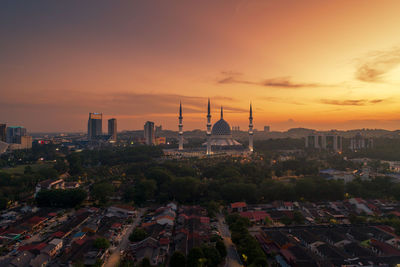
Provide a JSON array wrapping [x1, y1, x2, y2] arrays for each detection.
[[256, 225, 400, 267]]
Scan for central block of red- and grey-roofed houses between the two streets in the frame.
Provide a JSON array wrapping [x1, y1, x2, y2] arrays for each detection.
[[126, 203, 211, 265]]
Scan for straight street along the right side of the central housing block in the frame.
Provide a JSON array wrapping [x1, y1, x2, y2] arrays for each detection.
[[217, 214, 243, 267]]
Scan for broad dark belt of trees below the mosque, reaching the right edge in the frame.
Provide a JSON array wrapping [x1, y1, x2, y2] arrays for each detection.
[[122, 158, 400, 204]]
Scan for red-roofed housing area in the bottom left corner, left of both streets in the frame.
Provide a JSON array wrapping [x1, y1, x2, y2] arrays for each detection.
[[0, 206, 136, 267]]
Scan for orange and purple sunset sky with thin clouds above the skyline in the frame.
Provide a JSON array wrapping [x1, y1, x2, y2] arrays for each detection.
[[0, 0, 400, 132]]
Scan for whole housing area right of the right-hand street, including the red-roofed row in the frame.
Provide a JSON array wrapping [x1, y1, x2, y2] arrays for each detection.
[[228, 198, 400, 267]]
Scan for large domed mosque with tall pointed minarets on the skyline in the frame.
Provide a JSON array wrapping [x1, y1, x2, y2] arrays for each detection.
[[167, 99, 253, 156]]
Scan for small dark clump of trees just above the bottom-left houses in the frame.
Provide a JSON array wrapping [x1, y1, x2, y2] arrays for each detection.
[[36, 188, 87, 208]]
